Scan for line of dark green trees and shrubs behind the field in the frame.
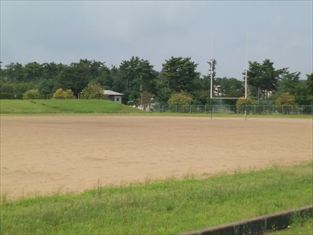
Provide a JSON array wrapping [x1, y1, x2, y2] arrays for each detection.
[[0, 57, 313, 105]]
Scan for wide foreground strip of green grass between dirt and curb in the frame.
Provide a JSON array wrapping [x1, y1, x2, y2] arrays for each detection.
[[0, 163, 313, 234]]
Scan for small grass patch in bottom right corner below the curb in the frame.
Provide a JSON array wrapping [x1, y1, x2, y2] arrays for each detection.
[[268, 218, 313, 235]]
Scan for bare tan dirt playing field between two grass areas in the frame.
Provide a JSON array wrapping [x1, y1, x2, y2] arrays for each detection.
[[0, 116, 312, 198]]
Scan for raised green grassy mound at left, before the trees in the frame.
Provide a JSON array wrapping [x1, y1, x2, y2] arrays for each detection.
[[0, 100, 139, 114]]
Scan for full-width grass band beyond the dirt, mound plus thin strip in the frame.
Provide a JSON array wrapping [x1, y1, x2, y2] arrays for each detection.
[[0, 99, 312, 119]]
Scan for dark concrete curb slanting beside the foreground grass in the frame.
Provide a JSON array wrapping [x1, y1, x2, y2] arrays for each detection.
[[182, 205, 313, 235]]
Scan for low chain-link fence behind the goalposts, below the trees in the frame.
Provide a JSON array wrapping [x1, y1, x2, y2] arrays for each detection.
[[150, 104, 313, 115]]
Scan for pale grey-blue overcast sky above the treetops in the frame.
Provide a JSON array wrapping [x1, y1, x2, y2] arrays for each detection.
[[1, 0, 313, 78]]
